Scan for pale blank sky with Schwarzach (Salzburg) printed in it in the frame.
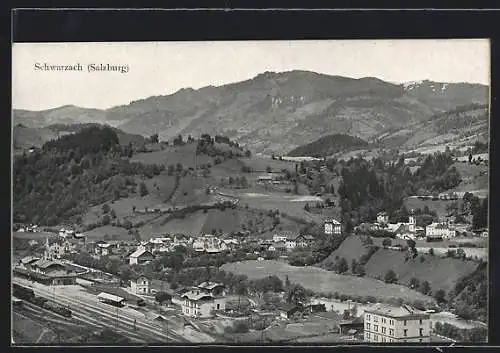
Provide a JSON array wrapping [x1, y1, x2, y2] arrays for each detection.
[[12, 39, 490, 110]]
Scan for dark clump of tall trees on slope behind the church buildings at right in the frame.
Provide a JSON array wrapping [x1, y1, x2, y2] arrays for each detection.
[[338, 153, 461, 224]]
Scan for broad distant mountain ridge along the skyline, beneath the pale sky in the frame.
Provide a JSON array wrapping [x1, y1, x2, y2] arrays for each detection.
[[14, 70, 488, 153]]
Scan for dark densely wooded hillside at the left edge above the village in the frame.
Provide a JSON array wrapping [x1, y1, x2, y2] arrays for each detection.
[[13, 126, 164, 226]]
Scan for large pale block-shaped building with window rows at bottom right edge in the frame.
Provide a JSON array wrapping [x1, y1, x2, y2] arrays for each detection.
[[364, 304, 431, 343]]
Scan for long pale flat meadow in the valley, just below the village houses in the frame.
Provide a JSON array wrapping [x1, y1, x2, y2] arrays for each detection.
[[221, 261, 431, 301]]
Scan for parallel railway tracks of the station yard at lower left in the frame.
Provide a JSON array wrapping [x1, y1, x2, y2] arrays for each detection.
[[13, 277, 189, 343]]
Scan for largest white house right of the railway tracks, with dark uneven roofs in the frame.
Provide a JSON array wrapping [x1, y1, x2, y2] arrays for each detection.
[[181, 282, 226, 318]]
